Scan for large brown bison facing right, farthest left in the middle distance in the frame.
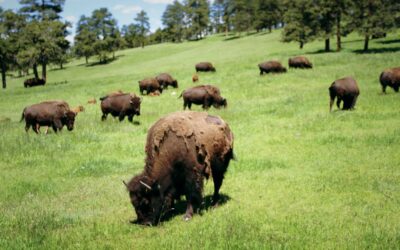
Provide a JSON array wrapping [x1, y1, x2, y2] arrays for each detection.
[[21, 101, 77, 134]]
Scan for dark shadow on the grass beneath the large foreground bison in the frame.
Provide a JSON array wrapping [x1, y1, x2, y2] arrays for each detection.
[[131, 194, 231, 225]]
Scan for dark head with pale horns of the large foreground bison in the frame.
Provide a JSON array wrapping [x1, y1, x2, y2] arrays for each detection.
[[126, 175, 163, 225]]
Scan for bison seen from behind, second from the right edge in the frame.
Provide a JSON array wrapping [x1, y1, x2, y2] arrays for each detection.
[[329, 77, 360, 111]]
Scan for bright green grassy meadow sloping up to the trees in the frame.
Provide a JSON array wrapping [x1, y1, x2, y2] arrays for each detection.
[[0, 31, 400, 249]]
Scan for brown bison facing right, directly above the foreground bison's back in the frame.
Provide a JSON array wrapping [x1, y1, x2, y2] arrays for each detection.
[[179, 85, 227, 109]]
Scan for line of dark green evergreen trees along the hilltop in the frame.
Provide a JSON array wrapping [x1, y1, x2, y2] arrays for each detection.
[[0, 0, 400, 88]]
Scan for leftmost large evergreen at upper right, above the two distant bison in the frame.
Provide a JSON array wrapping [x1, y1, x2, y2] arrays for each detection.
[[282, 0, 319, 49]]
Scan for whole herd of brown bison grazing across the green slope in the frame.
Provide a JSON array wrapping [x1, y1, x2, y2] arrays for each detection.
[[21, 59, 400, 225]]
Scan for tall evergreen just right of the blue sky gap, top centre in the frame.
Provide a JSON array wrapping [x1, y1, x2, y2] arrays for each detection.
[[162, 0, 185, 42]]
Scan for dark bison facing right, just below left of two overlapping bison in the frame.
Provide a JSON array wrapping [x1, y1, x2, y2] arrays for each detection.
[[100, 93, 142, 122]]
